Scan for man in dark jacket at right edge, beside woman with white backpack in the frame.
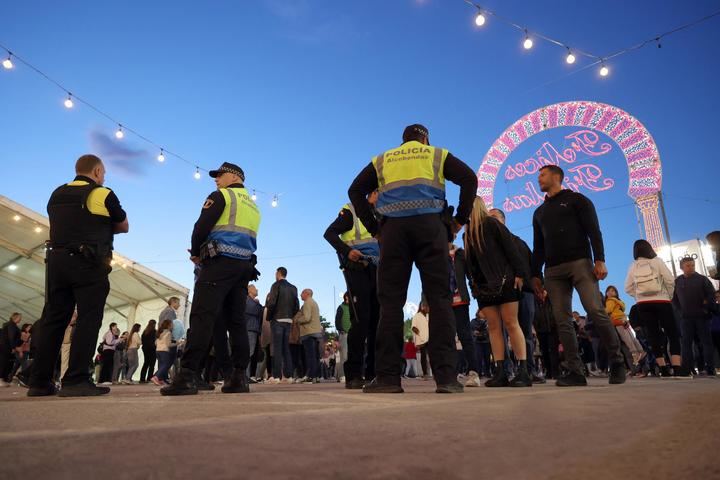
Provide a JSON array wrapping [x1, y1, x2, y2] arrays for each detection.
[[673, 257, 715, 377]]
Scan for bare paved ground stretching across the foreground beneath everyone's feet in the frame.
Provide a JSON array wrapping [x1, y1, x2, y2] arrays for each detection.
[[0, 379, 720, 480]]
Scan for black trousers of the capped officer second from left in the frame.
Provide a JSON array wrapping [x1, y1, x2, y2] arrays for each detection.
[[182, 256, 253, 373]]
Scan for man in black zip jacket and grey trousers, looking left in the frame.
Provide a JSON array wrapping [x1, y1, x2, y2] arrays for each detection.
[[532, 165, 627, 387]]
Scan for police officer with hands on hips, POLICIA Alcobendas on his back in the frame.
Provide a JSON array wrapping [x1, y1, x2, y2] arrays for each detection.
[[348, 124, 477, 393]]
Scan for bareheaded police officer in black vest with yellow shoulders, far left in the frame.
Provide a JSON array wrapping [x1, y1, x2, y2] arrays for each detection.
[[28, 155, 129, 397]]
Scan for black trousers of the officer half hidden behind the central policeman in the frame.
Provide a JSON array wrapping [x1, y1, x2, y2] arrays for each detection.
[[344, 264, 380, 380]]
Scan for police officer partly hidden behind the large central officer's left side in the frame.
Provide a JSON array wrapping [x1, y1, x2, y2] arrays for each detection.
[[324, 191, 380, 389]]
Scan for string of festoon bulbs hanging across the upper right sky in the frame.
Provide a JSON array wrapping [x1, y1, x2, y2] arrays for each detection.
[[463, 0, 720, 77]]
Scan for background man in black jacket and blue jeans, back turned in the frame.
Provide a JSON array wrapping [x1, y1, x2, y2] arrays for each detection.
[[265, 267, 300, 383]]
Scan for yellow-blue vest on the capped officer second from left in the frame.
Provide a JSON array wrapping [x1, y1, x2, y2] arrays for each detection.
[[209, 187, 260, 260]]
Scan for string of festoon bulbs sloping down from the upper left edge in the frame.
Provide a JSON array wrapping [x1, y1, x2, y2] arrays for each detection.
[[0, 44, 281, 207]]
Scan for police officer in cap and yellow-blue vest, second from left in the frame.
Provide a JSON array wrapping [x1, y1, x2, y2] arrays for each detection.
[[160, 162, 260, 395]]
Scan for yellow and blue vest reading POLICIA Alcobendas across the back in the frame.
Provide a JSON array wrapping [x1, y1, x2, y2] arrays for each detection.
[[372, 141, 448, 217]]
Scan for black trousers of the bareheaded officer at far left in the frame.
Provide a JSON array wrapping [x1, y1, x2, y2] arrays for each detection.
[[30, 250, 111, 387]]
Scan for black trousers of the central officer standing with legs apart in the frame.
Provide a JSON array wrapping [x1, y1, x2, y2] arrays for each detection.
[[375, 214, 457, 384]]
